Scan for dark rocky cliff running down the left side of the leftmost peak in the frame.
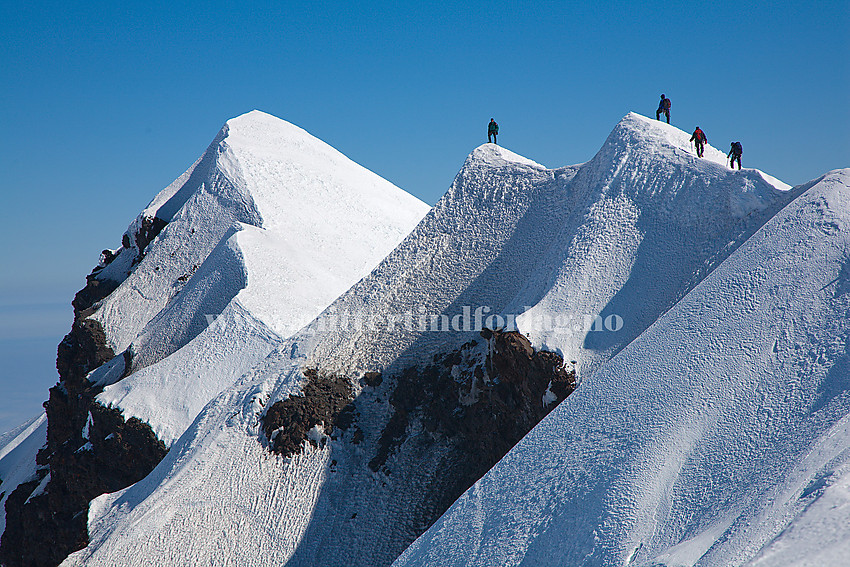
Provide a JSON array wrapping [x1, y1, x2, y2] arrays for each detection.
[[0, 219, 166, 567]]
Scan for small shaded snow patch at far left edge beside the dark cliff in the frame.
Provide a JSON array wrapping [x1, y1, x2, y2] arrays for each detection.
[[0, 413, 47, 534]]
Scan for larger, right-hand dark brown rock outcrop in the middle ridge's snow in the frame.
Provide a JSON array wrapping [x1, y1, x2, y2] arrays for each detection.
[[369, 330, 575, 474]]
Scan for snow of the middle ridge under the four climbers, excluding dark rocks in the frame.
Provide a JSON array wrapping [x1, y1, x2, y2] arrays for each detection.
[[61, 114, 794, 565]]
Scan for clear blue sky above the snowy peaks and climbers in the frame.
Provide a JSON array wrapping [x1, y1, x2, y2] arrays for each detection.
[[0, 0, 850, 430]]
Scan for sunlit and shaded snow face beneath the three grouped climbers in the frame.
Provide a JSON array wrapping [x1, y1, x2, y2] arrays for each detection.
[[507, 113, 792, 375]]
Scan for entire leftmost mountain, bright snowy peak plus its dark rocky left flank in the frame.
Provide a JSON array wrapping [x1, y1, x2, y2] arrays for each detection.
[[0, 111, 428, 564]]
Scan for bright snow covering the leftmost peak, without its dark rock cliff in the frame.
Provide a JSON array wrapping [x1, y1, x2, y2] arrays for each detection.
[[89, 111, 429, 445]]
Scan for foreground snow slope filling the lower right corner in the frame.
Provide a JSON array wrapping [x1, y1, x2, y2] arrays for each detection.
[[394, 169, 850, 567]]
